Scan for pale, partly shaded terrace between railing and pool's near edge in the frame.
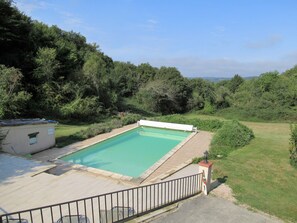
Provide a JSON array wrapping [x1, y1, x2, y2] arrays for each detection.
[[0, 153, 130, 214]]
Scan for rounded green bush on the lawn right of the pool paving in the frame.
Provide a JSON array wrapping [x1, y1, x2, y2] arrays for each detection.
[[210, 121, 255, 157]]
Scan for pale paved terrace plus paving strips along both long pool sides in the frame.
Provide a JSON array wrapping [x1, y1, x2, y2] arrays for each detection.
[[0, 124, 212, 214]]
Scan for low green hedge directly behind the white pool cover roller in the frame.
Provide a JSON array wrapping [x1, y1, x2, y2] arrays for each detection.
[[154, 114, 223, 132]]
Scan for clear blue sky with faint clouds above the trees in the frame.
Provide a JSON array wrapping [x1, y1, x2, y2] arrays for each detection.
[[14, 0, 297, 77]]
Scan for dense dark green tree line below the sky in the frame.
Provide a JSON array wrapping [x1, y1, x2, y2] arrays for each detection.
[[0, 0, 297, 122]]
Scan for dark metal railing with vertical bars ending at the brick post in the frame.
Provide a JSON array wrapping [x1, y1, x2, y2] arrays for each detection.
[[0, 173, 202, 223]]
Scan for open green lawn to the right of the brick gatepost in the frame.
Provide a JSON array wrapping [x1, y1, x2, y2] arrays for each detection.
[[209, 122, 297, 222]]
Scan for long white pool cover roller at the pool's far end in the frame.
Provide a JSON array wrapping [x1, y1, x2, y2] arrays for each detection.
[[138, 120, 197, 132]]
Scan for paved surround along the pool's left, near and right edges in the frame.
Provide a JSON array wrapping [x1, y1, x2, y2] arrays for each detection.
[[32, 123, 212, 185]]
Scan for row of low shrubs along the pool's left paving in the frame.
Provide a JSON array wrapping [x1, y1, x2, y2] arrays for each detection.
[[57, 114, 141, 147]]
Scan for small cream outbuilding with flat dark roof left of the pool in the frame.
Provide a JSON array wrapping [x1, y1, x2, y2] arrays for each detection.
[[0, 119, 57, 155]]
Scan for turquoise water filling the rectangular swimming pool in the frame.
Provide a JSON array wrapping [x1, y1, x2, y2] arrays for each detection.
[[61, 127, 190, 177]]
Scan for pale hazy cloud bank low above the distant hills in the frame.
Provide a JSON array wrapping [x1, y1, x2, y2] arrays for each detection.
[[149, 52, 297, 77]]
